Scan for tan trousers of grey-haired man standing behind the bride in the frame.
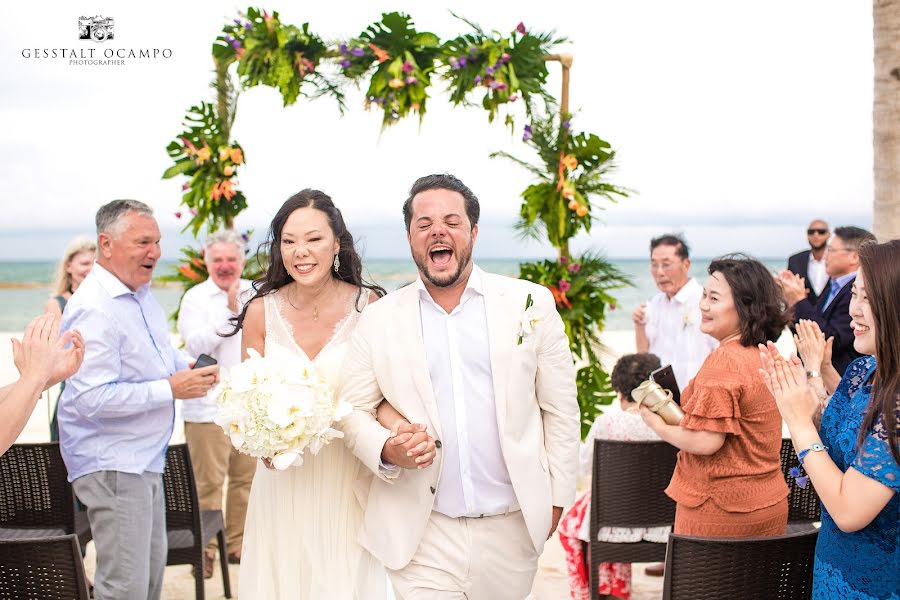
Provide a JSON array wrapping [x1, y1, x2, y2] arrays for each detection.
[[184, 422, 256, 554]]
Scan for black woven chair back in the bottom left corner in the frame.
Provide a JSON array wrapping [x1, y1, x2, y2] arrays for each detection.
[[0, 535, 90, 600]]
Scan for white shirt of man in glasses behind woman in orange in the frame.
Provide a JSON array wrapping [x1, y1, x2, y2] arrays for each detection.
[[645, 277, 719, 390]]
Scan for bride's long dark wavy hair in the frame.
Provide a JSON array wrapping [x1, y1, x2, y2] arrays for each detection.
[[226, 189, 386, 337]]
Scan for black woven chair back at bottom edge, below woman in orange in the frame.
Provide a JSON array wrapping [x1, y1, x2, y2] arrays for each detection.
[[663, 530, 819, 600]]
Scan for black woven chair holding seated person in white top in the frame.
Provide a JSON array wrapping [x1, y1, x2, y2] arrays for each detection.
[[588, 440, 678, 599]]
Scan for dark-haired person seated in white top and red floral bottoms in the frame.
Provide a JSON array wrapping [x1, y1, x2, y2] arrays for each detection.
[[559, 353, 669, 600]]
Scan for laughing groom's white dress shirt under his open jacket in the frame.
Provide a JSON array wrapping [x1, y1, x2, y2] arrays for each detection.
[[416, 267, 518, 518]]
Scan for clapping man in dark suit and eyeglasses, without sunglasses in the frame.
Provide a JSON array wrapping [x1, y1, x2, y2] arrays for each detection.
[[780, 227, 875, 375]]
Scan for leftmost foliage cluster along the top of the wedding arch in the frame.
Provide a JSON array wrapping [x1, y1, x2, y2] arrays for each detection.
[[213, 8, 345, 112]]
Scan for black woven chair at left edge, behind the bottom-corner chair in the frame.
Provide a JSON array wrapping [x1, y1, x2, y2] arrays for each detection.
[[0, 442, 91, 548]]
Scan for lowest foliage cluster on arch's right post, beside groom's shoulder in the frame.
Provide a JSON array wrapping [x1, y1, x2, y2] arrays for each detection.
[[519, 252, 631, 438]]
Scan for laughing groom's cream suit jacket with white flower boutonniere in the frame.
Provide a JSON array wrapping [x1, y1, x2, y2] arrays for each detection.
[[339, 273, 580, 569]]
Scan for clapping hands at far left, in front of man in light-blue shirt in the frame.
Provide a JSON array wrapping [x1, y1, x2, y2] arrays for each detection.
[[12, 313, 84, 389]]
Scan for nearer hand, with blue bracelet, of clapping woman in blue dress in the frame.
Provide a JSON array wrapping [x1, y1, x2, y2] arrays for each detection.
[[759, 342, 820, 428]]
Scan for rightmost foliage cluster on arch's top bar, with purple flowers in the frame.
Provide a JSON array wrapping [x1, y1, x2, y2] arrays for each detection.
[[440, 15, 566, 127]]
